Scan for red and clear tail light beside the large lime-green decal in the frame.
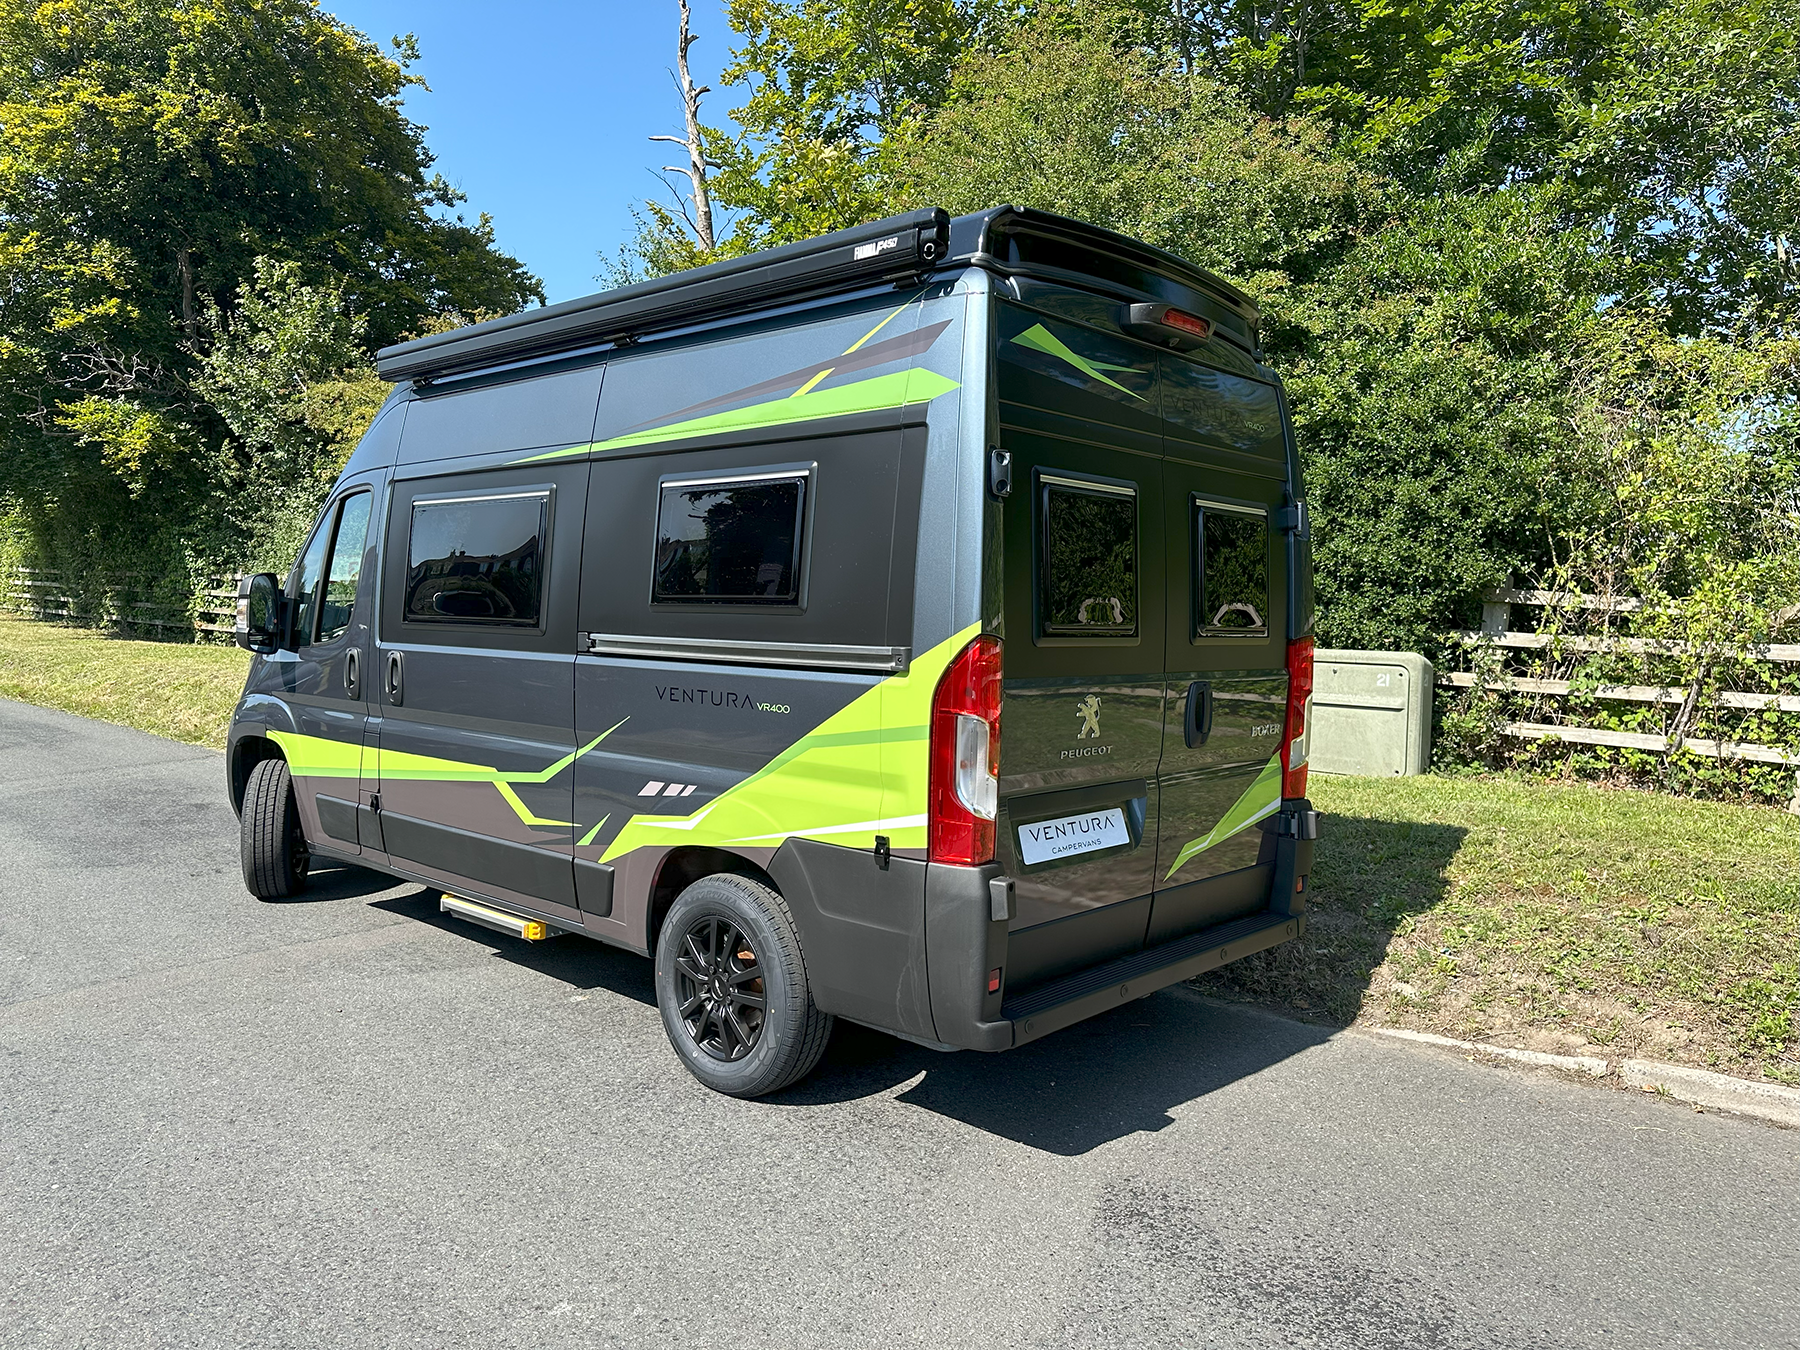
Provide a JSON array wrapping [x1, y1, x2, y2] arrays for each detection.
[[931, 635, 1001, 866]]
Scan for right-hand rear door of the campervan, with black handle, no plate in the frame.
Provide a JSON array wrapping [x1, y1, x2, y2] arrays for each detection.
[[1147, 356, 1287, 945]]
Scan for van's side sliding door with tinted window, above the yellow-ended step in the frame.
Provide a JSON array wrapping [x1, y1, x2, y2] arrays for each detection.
[[373, 461, 587, 922]]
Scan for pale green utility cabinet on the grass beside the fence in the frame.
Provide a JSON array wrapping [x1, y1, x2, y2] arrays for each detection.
[[1307, 648, 1435, 778]]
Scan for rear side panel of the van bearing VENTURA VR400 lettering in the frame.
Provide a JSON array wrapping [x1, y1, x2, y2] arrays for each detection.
[[574, 292, 967, 1008]]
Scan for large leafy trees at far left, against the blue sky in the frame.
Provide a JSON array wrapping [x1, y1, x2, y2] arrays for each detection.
[[0, 0, 542, 601]]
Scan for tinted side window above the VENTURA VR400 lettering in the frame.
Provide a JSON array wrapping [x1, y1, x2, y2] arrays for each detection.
[[653, 475, 806, 605]]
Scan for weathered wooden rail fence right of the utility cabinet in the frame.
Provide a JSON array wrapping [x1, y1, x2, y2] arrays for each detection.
[[1438, 589, 1800, 812]]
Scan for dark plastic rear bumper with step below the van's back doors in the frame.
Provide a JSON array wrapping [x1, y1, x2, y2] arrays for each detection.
[[925, 797, 1318, 1049]]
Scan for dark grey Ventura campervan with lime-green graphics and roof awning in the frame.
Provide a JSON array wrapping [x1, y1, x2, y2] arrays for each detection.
[[227, 207, 1318, 1096]]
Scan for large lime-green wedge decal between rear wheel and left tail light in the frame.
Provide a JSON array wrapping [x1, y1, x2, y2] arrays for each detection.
[[601, 625, 977, 862]]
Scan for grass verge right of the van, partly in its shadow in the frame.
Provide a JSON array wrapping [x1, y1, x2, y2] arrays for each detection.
[[1195, 776, 1800, 1084]]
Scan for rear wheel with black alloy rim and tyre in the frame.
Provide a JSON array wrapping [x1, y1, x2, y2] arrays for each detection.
[[657, 873, 833, 1096]]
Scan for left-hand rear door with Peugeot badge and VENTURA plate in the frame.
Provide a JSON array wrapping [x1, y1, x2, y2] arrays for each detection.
[[995, 304, 1166, 992]]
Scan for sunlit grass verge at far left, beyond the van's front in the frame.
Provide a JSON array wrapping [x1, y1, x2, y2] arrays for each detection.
[[0, 617, 250, 749]]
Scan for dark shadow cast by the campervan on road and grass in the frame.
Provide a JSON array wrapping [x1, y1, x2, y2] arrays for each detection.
[[351, 817, 1465, 1156]]
